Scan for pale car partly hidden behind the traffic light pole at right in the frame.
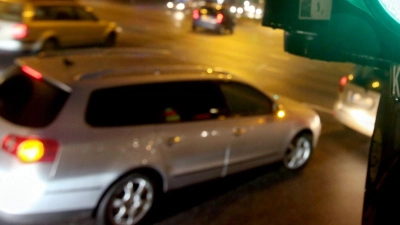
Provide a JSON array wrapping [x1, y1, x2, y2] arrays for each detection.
[[333, 66, 389, 137]]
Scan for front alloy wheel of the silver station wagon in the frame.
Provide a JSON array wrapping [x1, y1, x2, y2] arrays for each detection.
[[283, 133, 313, 170]]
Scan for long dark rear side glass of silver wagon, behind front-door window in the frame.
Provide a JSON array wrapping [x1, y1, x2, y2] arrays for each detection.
[[86, 82, 226, 127]]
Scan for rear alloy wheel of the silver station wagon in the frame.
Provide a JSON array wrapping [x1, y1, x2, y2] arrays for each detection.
[[96, 173, 158, 225]]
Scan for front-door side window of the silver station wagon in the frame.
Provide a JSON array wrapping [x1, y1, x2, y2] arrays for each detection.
[[221, 82, 273, 116]]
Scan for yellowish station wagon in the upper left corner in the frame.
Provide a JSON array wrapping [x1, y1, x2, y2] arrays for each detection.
[[0, 0, 118, 53]]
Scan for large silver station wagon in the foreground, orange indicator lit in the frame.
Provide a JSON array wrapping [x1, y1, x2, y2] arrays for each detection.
[[0, 48, 321, 225]]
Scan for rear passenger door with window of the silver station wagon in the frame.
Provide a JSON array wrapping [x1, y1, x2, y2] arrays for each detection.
[[156, 81, 231, 188]]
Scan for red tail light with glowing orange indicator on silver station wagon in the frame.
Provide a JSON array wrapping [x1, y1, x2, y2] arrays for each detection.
[[1, 135, 58, 163]]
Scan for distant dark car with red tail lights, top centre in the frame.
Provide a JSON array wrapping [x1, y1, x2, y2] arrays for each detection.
[[192, 3, 236, 34]]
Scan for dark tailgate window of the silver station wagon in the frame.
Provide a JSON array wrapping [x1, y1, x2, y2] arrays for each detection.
[[0, 67, 69, 127]]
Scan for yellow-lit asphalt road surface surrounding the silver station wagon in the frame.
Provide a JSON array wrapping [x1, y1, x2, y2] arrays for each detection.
[[2, 0, 370, 225]]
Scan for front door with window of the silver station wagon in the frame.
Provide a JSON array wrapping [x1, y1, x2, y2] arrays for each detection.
[[221, 82, 285, 174]]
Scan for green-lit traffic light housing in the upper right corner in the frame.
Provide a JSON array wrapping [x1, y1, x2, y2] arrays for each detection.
[[262, 0, 400, 65]]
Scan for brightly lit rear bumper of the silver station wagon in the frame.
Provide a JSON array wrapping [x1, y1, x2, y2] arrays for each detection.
[[0, 178, 103, 224]]
